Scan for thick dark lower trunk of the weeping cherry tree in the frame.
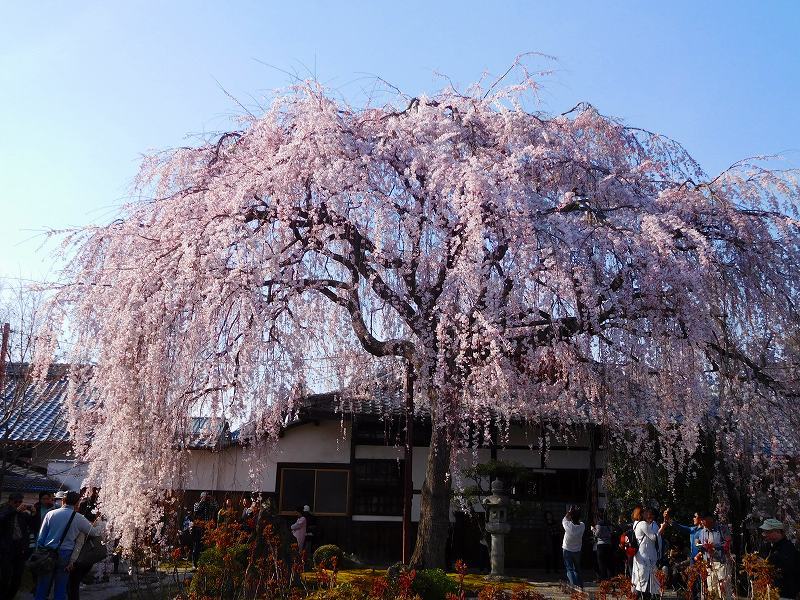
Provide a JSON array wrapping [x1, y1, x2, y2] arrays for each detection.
[[411, 424, 451, 569]]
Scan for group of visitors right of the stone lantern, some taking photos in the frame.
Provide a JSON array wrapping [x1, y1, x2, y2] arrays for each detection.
[[556, 506, 800, 600]]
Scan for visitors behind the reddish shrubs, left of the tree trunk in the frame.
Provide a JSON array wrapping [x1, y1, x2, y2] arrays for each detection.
[[181, 492, 319, 569]]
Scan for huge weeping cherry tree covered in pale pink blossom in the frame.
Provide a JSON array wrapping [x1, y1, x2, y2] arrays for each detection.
[[40, 71, 800, 566]]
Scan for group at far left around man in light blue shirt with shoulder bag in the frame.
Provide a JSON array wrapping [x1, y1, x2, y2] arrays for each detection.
[[0, 490, 110, 600]]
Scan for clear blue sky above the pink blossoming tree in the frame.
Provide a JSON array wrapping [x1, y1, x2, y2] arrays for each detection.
[[0, 0, 800, 279]]
